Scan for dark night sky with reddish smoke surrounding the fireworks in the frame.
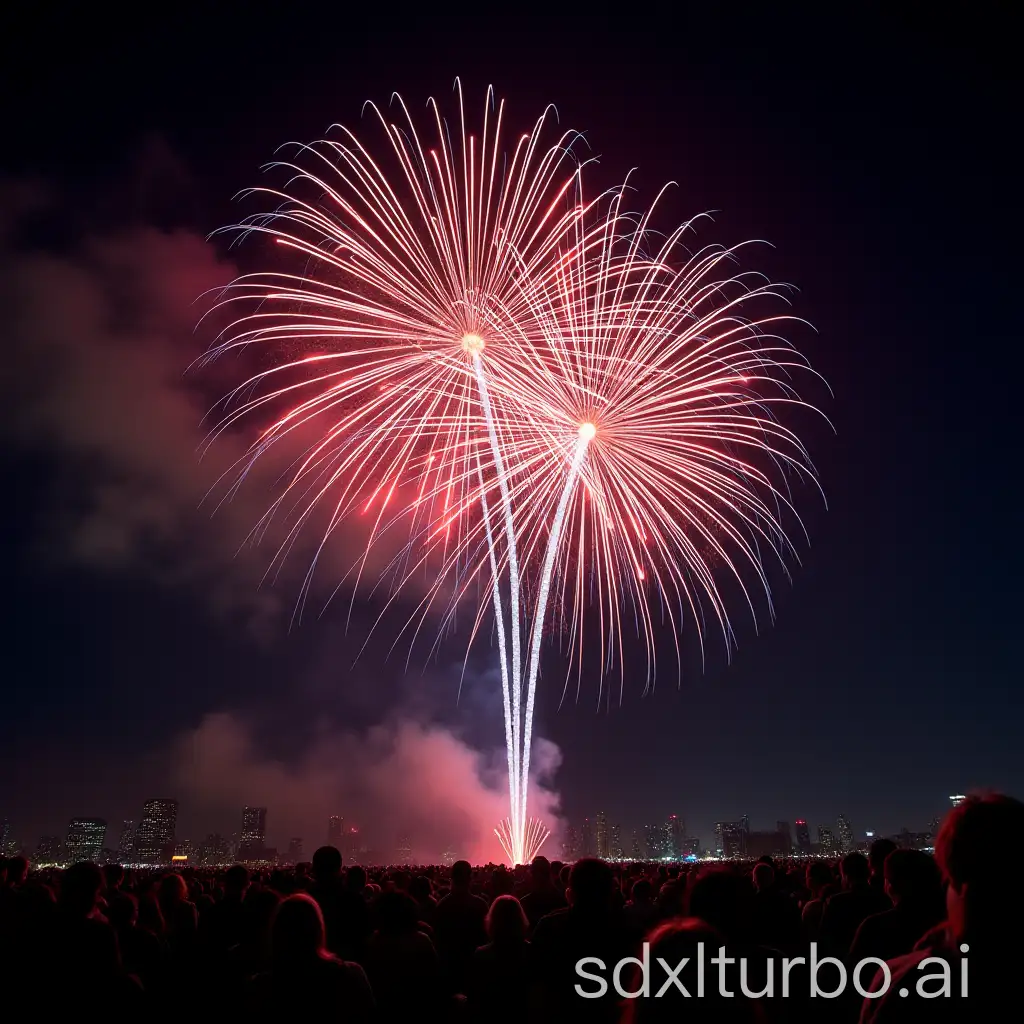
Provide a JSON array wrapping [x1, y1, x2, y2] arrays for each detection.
[[0, 3, 1024, 846]]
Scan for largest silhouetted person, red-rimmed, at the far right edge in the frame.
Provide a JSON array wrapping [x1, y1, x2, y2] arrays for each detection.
[[860, 796, 1024, 1024]]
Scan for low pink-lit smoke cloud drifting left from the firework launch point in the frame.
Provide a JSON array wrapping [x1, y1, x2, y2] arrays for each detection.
[[174, 713, 561, 863]]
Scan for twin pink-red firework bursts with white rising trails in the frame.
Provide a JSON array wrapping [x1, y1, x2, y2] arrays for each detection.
[[207, 90, 827, 863]]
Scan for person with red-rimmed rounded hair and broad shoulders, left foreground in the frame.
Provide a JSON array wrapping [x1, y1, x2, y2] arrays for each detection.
[[246, 893, 374, 1024]]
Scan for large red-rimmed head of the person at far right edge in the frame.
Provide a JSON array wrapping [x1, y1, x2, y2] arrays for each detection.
[[935, 795, 1024, 946]]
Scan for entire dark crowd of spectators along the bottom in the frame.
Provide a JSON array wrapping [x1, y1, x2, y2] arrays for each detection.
[[0, 796, 1024, 1024]]
